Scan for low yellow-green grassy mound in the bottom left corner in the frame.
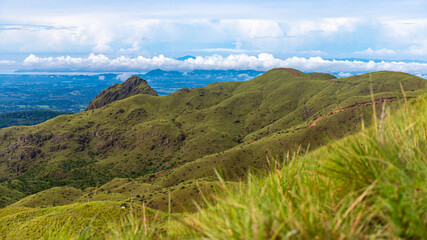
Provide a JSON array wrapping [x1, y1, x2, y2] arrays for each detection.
[[0, 201, 167, 239]]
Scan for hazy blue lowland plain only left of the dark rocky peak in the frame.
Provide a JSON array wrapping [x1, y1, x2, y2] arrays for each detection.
[[0, 73, 122, 113]]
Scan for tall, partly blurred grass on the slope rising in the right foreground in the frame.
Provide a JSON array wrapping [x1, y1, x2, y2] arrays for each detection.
[[182, 97, 427, 239]]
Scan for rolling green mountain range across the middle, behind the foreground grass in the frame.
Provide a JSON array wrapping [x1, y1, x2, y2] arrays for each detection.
[[0, 69, 426, 211]]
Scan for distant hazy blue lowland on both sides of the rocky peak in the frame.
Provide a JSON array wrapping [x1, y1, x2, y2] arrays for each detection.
[[0, 70, 263, 113]]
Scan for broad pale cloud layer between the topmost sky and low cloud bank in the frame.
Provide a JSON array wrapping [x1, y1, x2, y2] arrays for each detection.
[[0, 16, 427, 60]]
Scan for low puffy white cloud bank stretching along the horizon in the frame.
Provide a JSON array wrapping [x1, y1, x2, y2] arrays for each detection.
[[22, 53, 427, 75]]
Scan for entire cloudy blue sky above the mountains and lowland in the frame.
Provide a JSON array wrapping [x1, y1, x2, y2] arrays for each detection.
[[0, 0, 427, 75]]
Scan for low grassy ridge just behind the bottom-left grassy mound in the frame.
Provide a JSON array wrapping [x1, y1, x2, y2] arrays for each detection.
[[5, 178, 218, 212]]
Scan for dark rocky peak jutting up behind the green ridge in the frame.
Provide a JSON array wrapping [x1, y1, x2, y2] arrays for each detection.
[[85, 76, 157, 111]]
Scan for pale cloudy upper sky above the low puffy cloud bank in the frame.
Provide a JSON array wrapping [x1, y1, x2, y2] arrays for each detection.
[[0, 0, 427, 60]]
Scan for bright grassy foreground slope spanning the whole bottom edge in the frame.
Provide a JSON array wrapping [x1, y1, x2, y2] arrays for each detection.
[[0, 96, 427, 239]]
